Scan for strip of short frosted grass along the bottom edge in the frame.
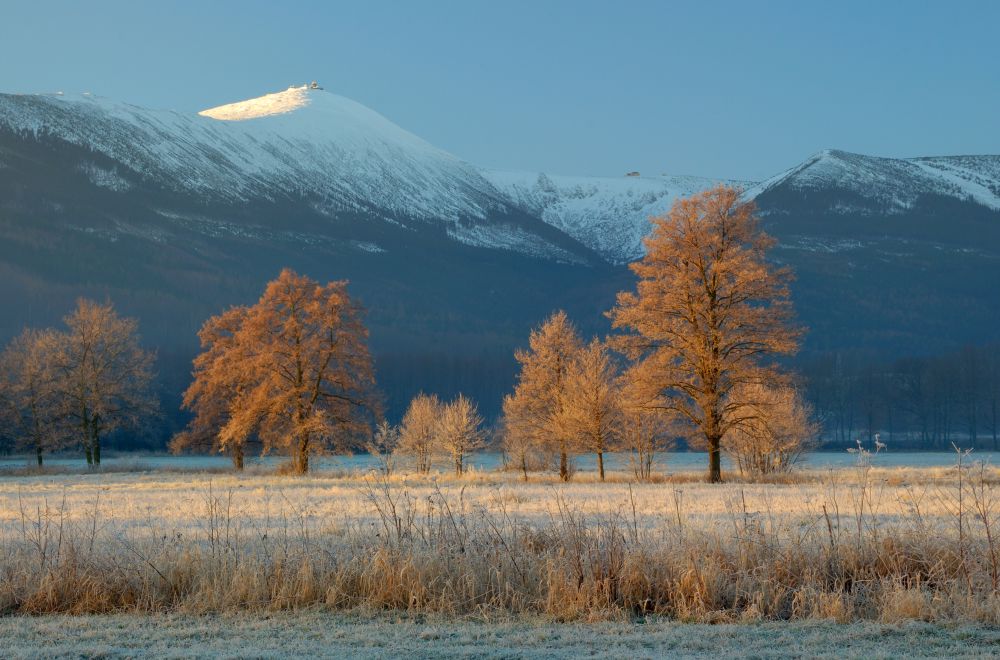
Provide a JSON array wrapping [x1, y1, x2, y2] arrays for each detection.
[[0, 611, 1000, 659]]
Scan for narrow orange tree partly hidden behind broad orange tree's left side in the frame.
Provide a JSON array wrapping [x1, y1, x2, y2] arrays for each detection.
[[170, 307, 252, 470]]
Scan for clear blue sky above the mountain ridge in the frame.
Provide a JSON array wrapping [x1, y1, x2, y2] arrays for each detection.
[[0, 0, 1000, 179]]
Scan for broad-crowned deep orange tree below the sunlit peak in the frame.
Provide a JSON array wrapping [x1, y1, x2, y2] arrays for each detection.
[[185, 269, 379, 474]]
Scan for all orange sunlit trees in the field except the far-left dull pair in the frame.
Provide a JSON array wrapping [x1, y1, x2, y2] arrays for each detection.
[[173, 186, 810, 481]]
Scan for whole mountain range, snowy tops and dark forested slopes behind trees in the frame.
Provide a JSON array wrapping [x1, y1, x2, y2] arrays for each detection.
[[0, 86, 1000, 372]]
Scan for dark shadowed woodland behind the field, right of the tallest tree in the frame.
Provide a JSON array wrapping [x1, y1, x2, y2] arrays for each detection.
[[801, 343, 1000, 451]]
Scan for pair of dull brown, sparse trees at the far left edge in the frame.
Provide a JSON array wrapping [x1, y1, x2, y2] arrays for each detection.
[[0, 299, 158, 466]]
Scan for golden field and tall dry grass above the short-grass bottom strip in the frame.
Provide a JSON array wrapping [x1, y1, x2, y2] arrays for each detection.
[[0, 458, 1000, 625]]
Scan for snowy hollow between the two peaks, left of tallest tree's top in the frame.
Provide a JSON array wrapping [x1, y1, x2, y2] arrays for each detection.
[[484, 170, 744, 263]]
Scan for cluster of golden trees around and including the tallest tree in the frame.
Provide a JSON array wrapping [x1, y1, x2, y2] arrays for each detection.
[[503, 186, 815, 482]]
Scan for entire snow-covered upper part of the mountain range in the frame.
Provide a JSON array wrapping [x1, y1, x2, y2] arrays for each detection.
[[0, 86, 1000, 263]]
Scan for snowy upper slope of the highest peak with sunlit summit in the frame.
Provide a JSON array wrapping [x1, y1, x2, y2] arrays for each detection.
[[0, 86, 503, 220]]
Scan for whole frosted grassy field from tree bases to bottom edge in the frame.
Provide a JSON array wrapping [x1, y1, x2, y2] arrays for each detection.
[[0, 453, 1000, 658]]
